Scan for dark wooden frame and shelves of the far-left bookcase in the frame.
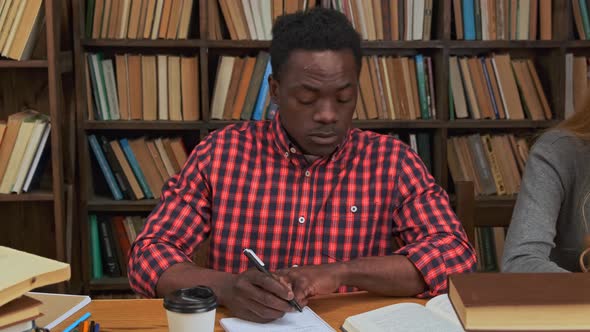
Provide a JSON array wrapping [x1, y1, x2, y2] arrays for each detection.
[[0, 0, 79, 291]]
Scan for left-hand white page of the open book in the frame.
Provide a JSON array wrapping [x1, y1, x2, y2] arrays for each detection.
[[343, 303, 463, 332]]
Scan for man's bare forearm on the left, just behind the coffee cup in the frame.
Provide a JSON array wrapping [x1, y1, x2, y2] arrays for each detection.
[[156, 263, 235, 304]]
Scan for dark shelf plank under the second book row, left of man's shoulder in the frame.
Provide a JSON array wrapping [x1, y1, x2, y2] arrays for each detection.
[[84, 120, 206, 131]]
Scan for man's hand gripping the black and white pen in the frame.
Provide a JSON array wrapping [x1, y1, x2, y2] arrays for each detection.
[[220, 269, 294, 323]]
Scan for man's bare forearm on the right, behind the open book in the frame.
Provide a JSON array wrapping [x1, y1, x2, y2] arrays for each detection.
[[340, 255, 426, 296]]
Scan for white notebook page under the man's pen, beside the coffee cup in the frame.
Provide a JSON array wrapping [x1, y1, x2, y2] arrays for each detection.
[[219, 307, 335, 332]]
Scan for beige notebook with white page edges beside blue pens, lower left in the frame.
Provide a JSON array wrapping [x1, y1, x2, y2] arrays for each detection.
[[27, 292, 90, 330]]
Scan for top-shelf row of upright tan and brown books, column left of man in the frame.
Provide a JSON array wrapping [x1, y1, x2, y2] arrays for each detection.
[[85, 0, 198, 39]]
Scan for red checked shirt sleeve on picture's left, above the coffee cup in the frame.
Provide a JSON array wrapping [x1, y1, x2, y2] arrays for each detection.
[[128, 140, 211, 297]]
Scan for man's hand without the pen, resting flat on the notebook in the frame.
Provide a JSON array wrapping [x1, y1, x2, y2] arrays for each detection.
[[277, 263, 345, 307]]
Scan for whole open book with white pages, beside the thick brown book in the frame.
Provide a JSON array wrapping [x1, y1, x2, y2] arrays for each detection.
[[342, 294, 463, 332]]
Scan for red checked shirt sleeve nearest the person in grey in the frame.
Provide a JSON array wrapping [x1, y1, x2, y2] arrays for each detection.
[[393, 148, 476, 297]]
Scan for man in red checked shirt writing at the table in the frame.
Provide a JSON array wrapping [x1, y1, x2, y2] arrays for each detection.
[[129, 9, 475, 322]]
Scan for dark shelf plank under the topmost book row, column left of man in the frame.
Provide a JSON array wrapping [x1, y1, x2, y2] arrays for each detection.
[[81, 39, 204, 49]]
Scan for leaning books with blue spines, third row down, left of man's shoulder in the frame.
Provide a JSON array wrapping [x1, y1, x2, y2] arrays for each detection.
[[88, 135, 187, 200]]
